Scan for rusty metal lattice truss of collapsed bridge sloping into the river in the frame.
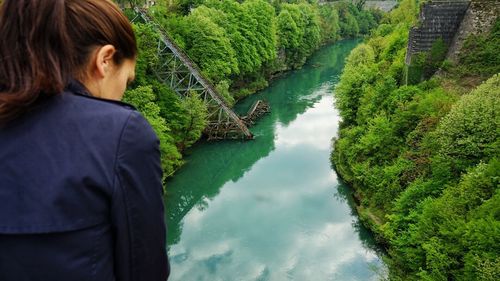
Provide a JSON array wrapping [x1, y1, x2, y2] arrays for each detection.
[[133, 7, 253, 139]]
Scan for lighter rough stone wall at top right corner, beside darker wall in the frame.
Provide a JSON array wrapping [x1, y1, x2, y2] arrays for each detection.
[[447, 0, 500, 62]]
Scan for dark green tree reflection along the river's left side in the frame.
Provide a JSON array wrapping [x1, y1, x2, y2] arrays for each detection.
[[165, 40, 359, 245]]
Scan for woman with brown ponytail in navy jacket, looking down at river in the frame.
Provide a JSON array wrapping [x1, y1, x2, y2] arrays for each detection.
[[0, 0, 169, 281]]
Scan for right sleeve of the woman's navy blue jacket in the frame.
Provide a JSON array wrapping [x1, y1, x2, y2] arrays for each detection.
[[111, 111, 170, 281]]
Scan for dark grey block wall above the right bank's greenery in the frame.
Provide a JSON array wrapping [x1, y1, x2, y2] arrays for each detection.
[[406, 0, 470, 65]]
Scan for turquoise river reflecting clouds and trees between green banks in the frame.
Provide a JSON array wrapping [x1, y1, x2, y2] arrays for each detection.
[[165, 40, 385, 281]]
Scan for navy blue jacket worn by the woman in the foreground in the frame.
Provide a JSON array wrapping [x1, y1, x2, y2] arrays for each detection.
[[0, 83, 169, 281]]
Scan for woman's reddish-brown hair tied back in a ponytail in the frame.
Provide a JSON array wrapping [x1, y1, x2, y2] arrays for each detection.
[[0, 0, 137, 124]]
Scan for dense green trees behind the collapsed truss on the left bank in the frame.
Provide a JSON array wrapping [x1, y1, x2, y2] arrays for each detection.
[[150, 0, 381, 98]]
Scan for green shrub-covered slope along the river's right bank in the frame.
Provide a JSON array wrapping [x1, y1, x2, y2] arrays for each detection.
[[331, 0, 500, 281]]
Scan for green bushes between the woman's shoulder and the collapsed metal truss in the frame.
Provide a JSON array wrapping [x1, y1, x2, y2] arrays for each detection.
[[123, 24, 207, 176]]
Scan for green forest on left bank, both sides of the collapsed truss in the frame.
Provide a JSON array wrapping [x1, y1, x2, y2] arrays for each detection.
[[118, 0, 382, 177]]
